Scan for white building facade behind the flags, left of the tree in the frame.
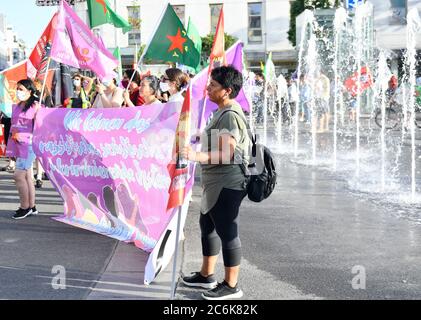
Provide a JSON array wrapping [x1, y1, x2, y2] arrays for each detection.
[[74, 0, 296, 74]]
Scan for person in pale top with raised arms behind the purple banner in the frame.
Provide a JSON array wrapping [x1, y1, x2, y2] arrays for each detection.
[[92, 79, 124, 108]]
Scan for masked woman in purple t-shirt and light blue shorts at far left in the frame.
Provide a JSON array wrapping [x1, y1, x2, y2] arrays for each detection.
[[6, 79, 41, 220]]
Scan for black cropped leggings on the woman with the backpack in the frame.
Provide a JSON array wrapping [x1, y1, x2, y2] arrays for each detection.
[[199, 188, 247, 267]]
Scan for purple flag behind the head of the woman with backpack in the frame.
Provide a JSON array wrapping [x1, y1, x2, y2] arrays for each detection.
[[192, 42, 250, 130]]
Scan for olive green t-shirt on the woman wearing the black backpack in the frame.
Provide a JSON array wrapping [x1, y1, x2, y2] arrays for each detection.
[[201, 104, 250, 214]]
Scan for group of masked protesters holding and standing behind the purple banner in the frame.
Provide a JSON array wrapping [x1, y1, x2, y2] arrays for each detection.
[[0, 68, 190, 212]]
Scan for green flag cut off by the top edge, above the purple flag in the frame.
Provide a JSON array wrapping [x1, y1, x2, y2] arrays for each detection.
[[88, 0, 132, 33]]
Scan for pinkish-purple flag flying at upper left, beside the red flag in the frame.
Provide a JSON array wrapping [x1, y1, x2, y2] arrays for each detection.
[[51, 1, 118, 79]]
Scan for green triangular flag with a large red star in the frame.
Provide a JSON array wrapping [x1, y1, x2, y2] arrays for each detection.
[[144, 5, 200, 68]]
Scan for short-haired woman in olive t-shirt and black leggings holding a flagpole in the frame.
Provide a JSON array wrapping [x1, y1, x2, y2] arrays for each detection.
[[180, 66, 250, 300]]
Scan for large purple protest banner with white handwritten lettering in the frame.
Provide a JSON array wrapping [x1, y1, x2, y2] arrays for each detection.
[[33, 103, 181, 252]]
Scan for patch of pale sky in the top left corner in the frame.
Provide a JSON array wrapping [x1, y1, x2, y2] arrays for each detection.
[[0, 0, 58, 48]]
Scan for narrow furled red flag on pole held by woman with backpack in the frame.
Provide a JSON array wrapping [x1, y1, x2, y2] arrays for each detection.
[[167, 88, 191, 210]]
